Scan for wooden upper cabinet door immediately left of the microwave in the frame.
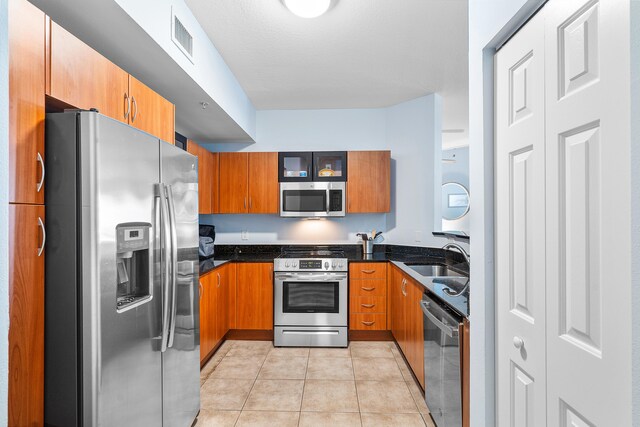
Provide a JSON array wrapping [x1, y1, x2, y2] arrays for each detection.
[[249, 153, 279, 214]]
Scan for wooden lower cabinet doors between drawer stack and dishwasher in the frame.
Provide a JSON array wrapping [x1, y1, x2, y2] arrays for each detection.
[[390, 267, 425, 388]]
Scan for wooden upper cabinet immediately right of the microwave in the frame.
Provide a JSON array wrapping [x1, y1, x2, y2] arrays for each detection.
[[347, 151, 391, 213]]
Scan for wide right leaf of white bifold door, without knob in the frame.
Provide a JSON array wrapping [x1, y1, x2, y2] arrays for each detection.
[[545, 0, 631, 427]]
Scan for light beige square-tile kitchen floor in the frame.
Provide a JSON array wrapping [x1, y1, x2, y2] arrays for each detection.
[[196, 341, 433, 427]]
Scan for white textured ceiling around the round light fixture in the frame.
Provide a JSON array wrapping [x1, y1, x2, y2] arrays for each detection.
[[186, 0, 468, 145]]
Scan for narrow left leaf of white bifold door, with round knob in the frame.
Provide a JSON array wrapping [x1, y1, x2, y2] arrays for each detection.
[[495, 10, 546, 427]]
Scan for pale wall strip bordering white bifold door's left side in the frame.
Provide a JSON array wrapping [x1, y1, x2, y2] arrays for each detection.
[[469, 0, 543, 426]]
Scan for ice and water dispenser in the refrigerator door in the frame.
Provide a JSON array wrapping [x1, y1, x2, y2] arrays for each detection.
[[116, 222, 153, 312]]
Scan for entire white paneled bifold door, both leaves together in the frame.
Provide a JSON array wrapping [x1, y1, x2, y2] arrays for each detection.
[[495, 0, 631, 427]]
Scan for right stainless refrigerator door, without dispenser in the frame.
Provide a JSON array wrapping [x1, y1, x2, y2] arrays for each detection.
[[160, 142, 200, 427]]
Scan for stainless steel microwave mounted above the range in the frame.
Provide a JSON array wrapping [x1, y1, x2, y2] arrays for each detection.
[[280, 181, 346, 218]]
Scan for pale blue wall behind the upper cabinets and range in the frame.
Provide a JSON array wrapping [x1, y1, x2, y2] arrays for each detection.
[[201, 95, 442, 246]]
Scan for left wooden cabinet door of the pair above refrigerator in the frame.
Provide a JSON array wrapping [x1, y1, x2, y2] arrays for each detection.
[[49, 22, 131, 122]]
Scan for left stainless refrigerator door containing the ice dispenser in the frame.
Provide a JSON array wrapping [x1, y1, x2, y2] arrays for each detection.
[[78, 112, 162, 426]]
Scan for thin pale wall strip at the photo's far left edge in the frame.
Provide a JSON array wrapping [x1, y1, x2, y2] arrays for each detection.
[[0, 0, 9, 425]]
